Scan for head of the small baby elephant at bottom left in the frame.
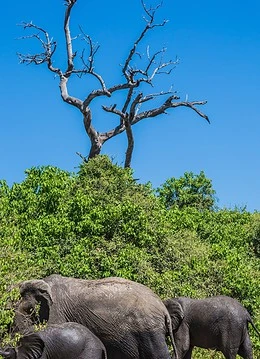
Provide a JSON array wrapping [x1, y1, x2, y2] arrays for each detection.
[[0, 334, 44, 359]]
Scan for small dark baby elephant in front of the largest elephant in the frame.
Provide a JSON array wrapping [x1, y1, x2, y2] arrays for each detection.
[[0, 322, 107, 359]]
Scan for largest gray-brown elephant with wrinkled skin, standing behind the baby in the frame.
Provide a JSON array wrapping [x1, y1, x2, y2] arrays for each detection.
[[14, 274, 178, 359]]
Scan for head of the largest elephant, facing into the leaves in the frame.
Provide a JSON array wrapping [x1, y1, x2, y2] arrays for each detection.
[[15, 280, 53, 331]]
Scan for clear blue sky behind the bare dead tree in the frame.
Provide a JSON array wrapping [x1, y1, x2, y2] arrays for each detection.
[[0, 0, 260, 211]]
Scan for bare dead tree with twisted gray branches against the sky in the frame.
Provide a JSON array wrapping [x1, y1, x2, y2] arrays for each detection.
[[18, 0, 209, 167]]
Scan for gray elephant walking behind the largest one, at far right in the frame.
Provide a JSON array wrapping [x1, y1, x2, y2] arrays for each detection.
[[164, 296, 259, 359]]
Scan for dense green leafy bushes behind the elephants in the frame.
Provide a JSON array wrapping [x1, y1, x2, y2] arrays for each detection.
[[0, 156, 260, 358]]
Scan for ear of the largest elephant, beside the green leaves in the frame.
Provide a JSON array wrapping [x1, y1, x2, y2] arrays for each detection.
[[19, 279, 53, 322]]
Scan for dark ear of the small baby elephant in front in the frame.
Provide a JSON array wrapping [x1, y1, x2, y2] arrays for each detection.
[[17, 333, 45, 359]]
